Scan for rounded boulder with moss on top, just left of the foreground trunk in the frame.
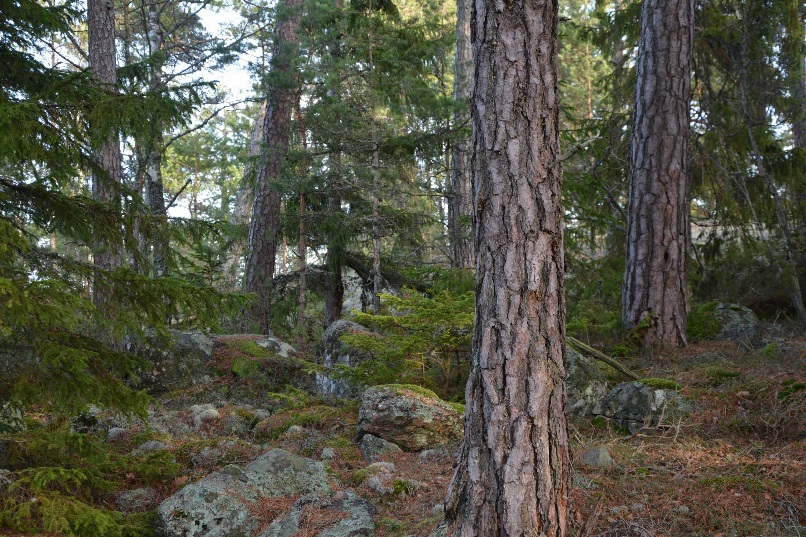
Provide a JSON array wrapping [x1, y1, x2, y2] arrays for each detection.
[[358, 384, 463, 451]]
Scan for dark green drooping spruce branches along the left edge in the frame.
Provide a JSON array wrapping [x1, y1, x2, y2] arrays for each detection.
[[0, 0, 248, 422]]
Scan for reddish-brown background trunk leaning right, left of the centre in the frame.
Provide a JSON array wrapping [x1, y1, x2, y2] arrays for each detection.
[[244, 0, 302, 333]]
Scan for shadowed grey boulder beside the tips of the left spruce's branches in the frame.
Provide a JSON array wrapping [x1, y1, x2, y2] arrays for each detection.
[[139, 330, 215, 395]]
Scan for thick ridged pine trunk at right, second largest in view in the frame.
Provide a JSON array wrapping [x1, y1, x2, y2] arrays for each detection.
[[622, 0, 694, 347]]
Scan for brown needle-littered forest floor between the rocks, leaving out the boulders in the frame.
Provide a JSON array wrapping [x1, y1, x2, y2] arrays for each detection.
[[0, 332, 806, 537]]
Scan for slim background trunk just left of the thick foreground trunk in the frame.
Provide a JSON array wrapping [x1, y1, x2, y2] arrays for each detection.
[[448, 0, 474, 268]]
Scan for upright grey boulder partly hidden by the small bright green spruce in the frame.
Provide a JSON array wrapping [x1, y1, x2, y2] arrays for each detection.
[[316, 319, 376, 398]]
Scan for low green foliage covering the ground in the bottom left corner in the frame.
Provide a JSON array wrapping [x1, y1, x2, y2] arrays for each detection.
[[0, 426, 180, 537]]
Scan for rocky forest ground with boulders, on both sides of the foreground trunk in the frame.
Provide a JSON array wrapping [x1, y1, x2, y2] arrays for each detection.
[[0, 310, 806, 537]]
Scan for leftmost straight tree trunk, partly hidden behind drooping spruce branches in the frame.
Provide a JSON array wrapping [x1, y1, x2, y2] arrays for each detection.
[[87, 0, 122, 309]]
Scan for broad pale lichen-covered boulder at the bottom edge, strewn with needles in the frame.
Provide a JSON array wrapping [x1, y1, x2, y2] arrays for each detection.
[[157, 449, 374, 537]]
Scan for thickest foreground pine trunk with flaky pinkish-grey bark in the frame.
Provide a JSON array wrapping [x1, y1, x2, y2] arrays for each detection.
[[446, 0, 571, 537]]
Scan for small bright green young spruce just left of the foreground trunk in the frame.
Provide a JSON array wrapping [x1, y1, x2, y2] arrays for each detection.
[[341, 289, 474, 397]]
